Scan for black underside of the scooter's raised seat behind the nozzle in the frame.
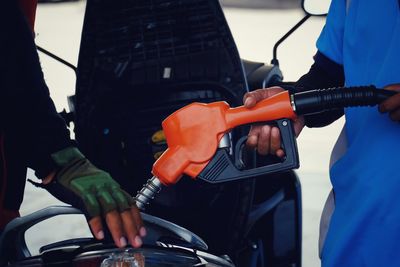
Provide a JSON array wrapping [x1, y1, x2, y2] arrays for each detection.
[[76, 0, 247, 188]]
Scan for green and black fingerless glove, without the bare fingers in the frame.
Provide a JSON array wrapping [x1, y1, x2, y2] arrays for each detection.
[[45, 147, 135, 219]]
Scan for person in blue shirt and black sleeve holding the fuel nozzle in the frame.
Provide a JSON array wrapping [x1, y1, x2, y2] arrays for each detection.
[[244, 0, 400, 267]]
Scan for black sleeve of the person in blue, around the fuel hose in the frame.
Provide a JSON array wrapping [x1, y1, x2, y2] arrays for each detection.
[[294, 52, 344, 127]]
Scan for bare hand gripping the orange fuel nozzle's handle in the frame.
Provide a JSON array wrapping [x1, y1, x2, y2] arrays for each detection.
[[243, 86, 305, 158]]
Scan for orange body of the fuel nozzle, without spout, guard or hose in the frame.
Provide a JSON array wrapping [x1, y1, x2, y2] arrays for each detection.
[[152, 91, 296, 185]]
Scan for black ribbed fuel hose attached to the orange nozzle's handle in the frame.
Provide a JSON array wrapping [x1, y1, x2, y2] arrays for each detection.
[[292, 86, 397, 115]]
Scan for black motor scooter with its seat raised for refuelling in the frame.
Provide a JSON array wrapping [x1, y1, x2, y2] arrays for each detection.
[[1, 0, 332, 266]]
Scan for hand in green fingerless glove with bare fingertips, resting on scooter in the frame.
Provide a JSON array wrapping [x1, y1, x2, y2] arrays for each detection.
[[43, 147, 146, 247]]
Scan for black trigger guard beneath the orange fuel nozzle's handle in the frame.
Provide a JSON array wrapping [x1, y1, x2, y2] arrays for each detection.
[[198, 119, 299, 183]]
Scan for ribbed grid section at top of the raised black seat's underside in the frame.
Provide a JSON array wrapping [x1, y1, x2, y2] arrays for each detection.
[[96, 1, 222, 64]]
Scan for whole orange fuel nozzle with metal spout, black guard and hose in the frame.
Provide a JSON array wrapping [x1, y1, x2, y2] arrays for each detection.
[[136, 86, 395, 210]]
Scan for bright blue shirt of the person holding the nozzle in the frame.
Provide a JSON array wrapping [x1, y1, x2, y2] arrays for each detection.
[[317, 0, 400, 267]]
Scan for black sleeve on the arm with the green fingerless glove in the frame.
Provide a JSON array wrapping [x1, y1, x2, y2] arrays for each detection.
[[0, 0, 73, 180]]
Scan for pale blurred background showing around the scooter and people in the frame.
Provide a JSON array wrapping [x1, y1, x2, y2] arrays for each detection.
[[21, 0, 343, 267]]
